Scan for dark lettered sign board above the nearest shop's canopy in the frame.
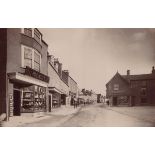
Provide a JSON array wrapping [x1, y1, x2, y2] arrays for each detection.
[[25, 67, 49, 83]]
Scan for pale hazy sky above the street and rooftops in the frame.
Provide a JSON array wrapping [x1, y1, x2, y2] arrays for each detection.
[[40, 28, 155, 95]]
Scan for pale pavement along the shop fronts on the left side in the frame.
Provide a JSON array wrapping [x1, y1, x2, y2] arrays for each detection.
[[2, 106, 81, 127]]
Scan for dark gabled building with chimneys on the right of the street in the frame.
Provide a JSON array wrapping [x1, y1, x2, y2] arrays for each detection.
[[106, 67, 155, 106]]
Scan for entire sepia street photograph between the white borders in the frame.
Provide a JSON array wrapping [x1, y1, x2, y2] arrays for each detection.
[[0, 28, 155, 127]]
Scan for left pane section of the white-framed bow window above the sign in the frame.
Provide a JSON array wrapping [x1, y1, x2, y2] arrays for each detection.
[[24, 47, 33, 68]]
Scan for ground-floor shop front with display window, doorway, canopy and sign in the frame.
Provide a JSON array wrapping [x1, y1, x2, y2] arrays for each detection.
[[8, 67, 49, 117]]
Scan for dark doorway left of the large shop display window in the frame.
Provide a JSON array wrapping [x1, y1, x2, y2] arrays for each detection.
[[13, 90, 21, 116]]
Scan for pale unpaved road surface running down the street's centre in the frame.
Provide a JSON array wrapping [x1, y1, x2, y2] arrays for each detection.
[[20, 104, 155, 127]]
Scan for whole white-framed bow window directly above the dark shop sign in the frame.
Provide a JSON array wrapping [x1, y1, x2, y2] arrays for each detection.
[[22, 45, 41, 72]]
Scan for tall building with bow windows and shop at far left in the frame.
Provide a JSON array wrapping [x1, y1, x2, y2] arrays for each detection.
[[0, 28, 49, 119]]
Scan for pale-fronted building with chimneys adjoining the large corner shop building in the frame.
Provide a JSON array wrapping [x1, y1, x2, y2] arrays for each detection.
[[48, 55, 69, 111]]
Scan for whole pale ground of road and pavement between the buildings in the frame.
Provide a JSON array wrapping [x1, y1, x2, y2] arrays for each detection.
[[2, 103, 155, 127]]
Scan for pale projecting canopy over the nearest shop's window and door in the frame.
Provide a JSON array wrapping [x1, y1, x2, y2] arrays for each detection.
[[8, 72, 48, 87]]
